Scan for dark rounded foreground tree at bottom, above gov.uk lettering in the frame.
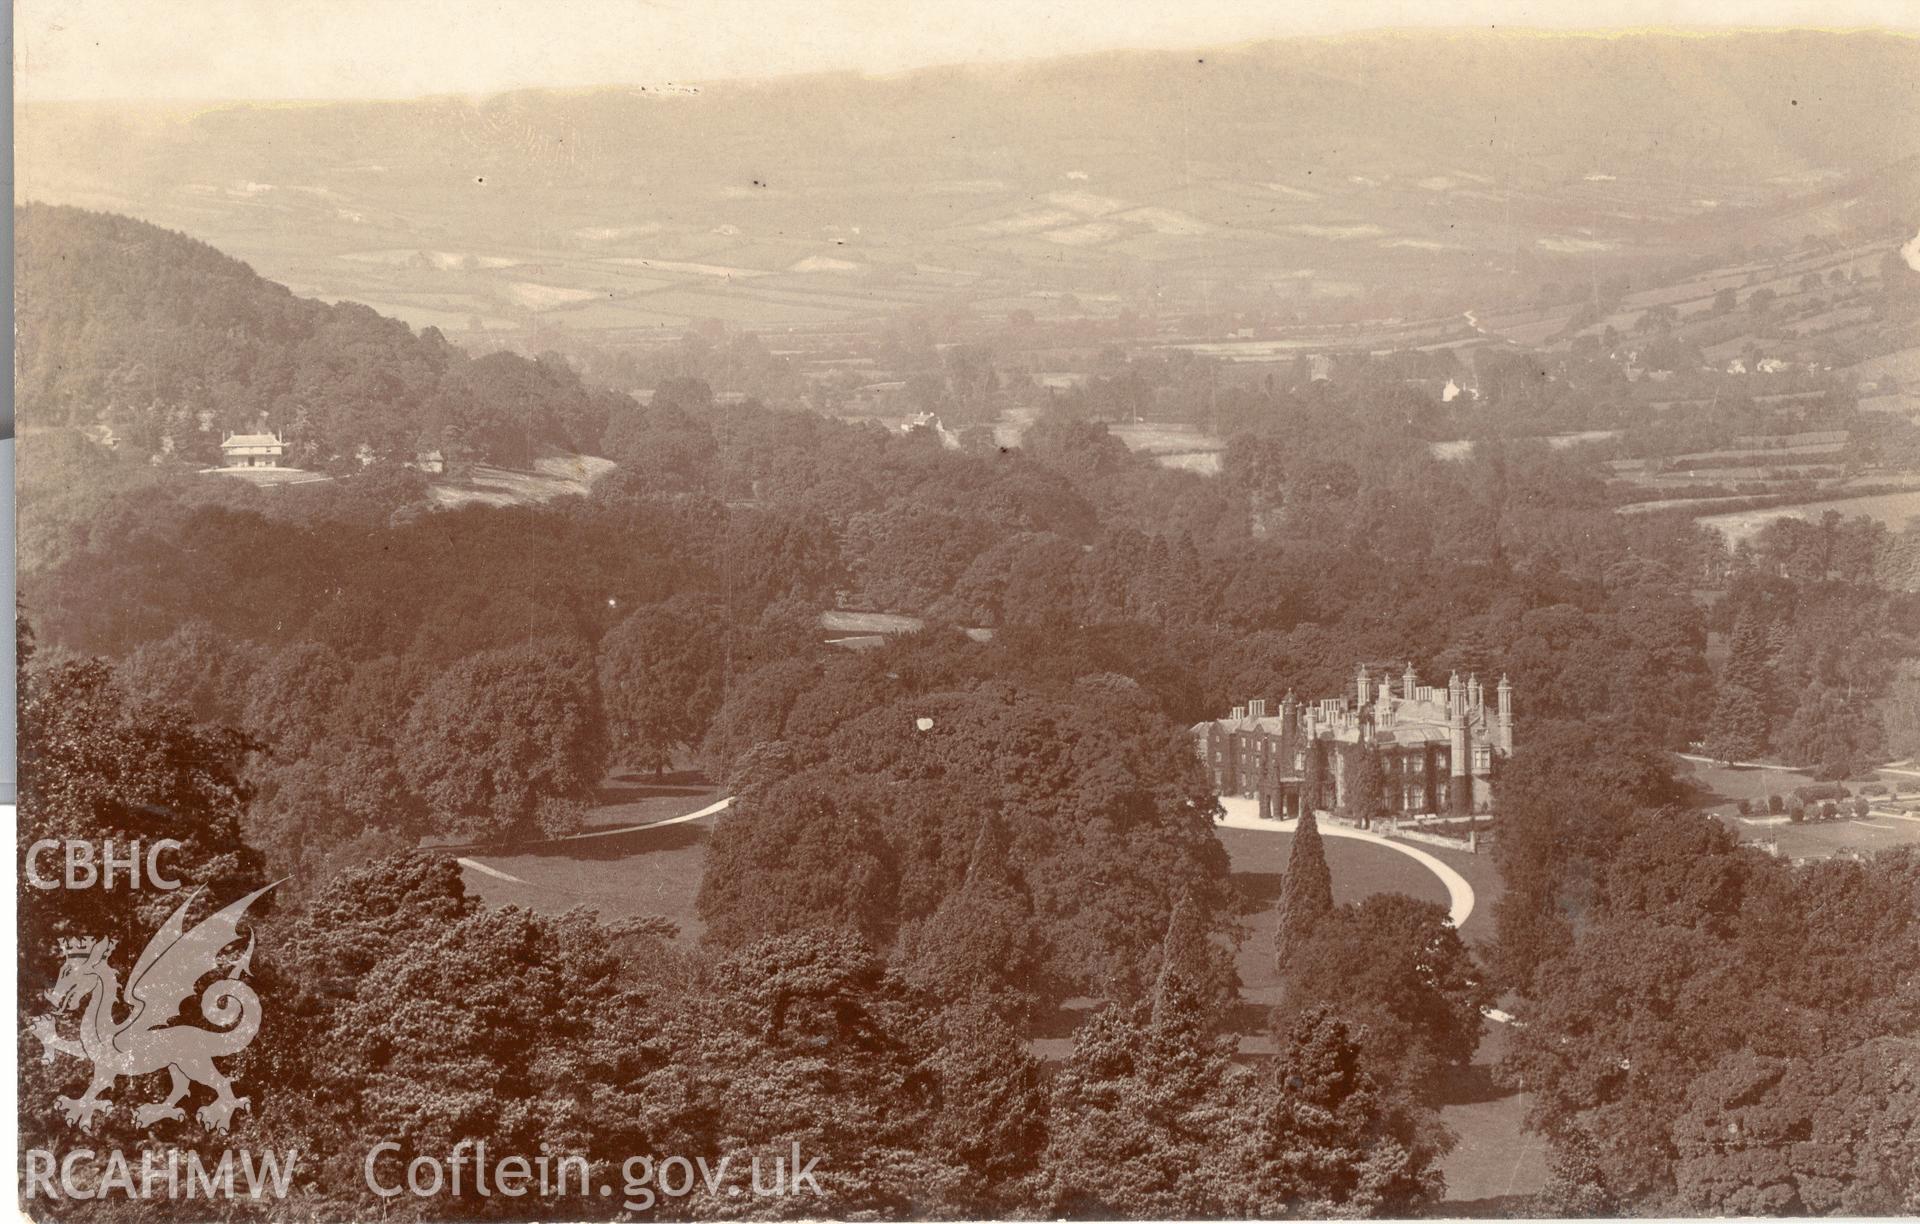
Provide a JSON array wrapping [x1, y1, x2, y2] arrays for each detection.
[[664, 930, 990, 1220]]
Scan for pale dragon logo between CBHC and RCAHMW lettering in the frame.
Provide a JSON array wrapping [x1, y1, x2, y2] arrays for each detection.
[[33, 884, 275, 1132]]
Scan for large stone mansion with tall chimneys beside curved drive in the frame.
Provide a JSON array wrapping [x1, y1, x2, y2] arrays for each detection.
[[1192, 664, 1513, 819]]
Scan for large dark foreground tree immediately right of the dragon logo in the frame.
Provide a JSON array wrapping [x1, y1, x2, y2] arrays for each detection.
[[246, 854, 685, 1218]]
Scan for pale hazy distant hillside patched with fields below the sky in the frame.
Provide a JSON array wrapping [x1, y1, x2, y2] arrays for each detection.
[[19, 33, 1920, 334]]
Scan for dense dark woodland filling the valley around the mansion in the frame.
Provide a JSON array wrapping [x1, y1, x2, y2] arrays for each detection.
[[19, 209, 1920, 1216]]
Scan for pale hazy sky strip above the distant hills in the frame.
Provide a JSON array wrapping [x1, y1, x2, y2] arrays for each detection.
[[13, 0, 1920, 100]]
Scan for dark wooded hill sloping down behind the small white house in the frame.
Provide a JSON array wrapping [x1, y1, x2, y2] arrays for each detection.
[[15, 205, 607, 468]]
